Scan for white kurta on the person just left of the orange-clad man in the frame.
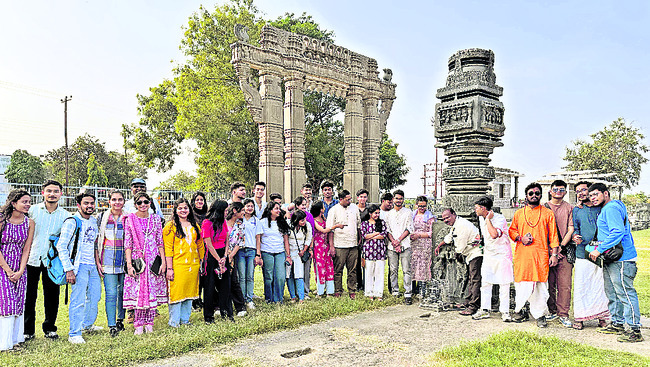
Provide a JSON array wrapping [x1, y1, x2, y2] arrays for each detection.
[[479, 213, 515, 284]]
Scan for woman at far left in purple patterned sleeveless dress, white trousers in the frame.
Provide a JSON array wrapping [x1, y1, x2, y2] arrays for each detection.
[[0, 189, 34, 351]]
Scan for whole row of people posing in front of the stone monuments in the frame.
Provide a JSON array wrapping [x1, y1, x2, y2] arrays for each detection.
[[0, 178, 643, 350]]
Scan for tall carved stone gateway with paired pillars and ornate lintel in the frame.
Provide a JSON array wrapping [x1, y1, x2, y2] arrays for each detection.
[[231, 25, 396, 202]]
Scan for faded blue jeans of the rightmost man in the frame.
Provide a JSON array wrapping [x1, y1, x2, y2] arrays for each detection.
[[603, 261, 641, 330]]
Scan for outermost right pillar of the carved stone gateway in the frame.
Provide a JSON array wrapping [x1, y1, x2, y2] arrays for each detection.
[[360, 96, 381, 203]]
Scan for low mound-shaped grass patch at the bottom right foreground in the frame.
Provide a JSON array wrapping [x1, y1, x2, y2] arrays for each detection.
[[429, 331, 650, 367]]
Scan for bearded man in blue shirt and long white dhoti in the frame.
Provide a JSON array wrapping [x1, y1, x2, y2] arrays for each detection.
[[573, 181, 610, 330]]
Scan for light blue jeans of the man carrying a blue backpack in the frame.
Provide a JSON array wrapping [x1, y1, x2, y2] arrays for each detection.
[[68, 264, 102, 336]]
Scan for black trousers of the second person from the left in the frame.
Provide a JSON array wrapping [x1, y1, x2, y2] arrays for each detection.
[[24, 264, 60, 335]]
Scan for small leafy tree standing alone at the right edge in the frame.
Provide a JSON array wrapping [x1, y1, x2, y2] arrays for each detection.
[[564, 118, 649, 189]]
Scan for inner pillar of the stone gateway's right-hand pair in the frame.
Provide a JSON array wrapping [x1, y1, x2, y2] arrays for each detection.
[[343, 87, 364, 195]]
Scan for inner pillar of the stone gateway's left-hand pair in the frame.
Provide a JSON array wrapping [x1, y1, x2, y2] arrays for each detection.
[[283, 77, 307, 202]]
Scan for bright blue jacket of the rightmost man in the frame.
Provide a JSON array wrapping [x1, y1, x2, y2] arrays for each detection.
[[596, 200, 637, 261]]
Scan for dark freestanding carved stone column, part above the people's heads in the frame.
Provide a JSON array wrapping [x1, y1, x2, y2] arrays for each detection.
[[433, 48, 505, 216]]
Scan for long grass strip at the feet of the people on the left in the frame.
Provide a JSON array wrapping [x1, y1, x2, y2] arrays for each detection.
[[0, 268, 402, 367]]
